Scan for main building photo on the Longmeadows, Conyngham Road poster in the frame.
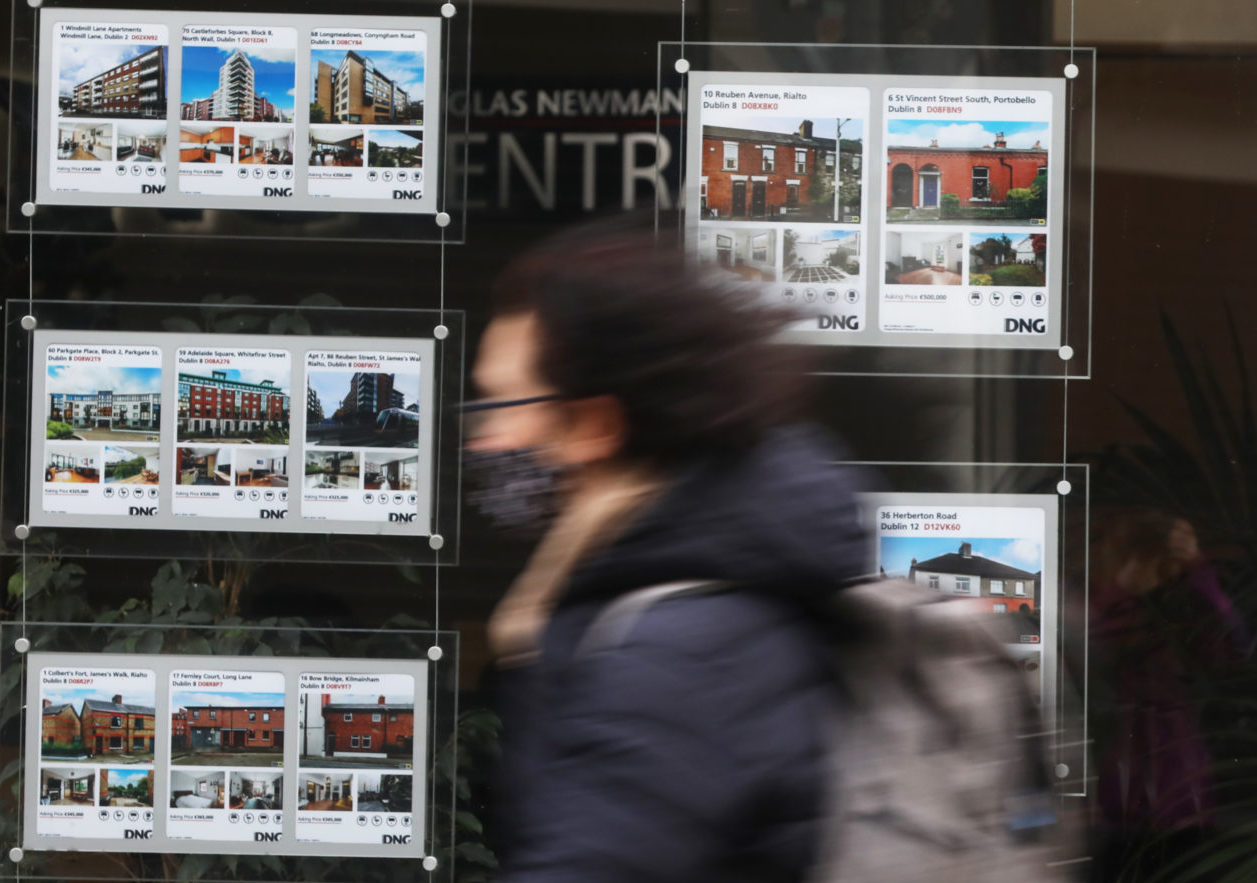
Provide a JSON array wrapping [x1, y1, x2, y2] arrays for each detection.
[[310, 49, 424, 126]]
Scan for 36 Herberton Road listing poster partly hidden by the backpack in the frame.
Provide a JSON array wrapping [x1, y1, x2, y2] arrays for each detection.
[[865, 493, 1058, 704]]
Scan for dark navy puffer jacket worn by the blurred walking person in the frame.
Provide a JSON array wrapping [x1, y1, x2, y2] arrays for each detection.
[[499, 429, 867, 883]]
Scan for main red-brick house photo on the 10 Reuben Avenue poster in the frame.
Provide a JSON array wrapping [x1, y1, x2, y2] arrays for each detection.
[[699, 116, 864, 223]]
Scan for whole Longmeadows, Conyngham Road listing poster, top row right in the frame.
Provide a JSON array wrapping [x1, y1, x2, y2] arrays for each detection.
[[307, 28, 427, 200]]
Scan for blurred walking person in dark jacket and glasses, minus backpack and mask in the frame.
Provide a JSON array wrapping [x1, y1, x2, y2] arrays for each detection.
[[469, 229, 869, 883]]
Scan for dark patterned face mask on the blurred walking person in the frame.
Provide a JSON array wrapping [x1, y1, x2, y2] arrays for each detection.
[[464, 448, 562, 538]]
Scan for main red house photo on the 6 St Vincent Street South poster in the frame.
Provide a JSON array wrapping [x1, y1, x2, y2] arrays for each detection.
[[886, 119, 1051, 224]]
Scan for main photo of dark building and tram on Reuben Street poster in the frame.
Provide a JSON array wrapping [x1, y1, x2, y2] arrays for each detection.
[[305, 370, 420, 450]]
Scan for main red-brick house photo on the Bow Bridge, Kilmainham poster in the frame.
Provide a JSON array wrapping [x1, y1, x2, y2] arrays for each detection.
[[298, 689, 415, 770]]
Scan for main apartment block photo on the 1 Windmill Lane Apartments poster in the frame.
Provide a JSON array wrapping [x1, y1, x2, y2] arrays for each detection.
[[58, 43, 170, 119]]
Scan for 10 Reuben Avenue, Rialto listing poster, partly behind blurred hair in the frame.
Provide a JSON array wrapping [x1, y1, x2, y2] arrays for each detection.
[[690, 83, 870, 332]]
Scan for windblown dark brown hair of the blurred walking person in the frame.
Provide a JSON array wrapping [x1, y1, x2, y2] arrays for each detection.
[[494, 224, 804, 463]]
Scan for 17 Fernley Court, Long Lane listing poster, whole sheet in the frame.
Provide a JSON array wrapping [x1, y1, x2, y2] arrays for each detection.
[[166, 670, 285, 843]]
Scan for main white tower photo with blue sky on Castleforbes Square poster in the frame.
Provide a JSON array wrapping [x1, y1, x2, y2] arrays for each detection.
[[178, 47, 297, 122]]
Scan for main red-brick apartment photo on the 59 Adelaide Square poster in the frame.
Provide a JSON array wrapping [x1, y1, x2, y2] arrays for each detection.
[[177, 366, 290, 444]]
